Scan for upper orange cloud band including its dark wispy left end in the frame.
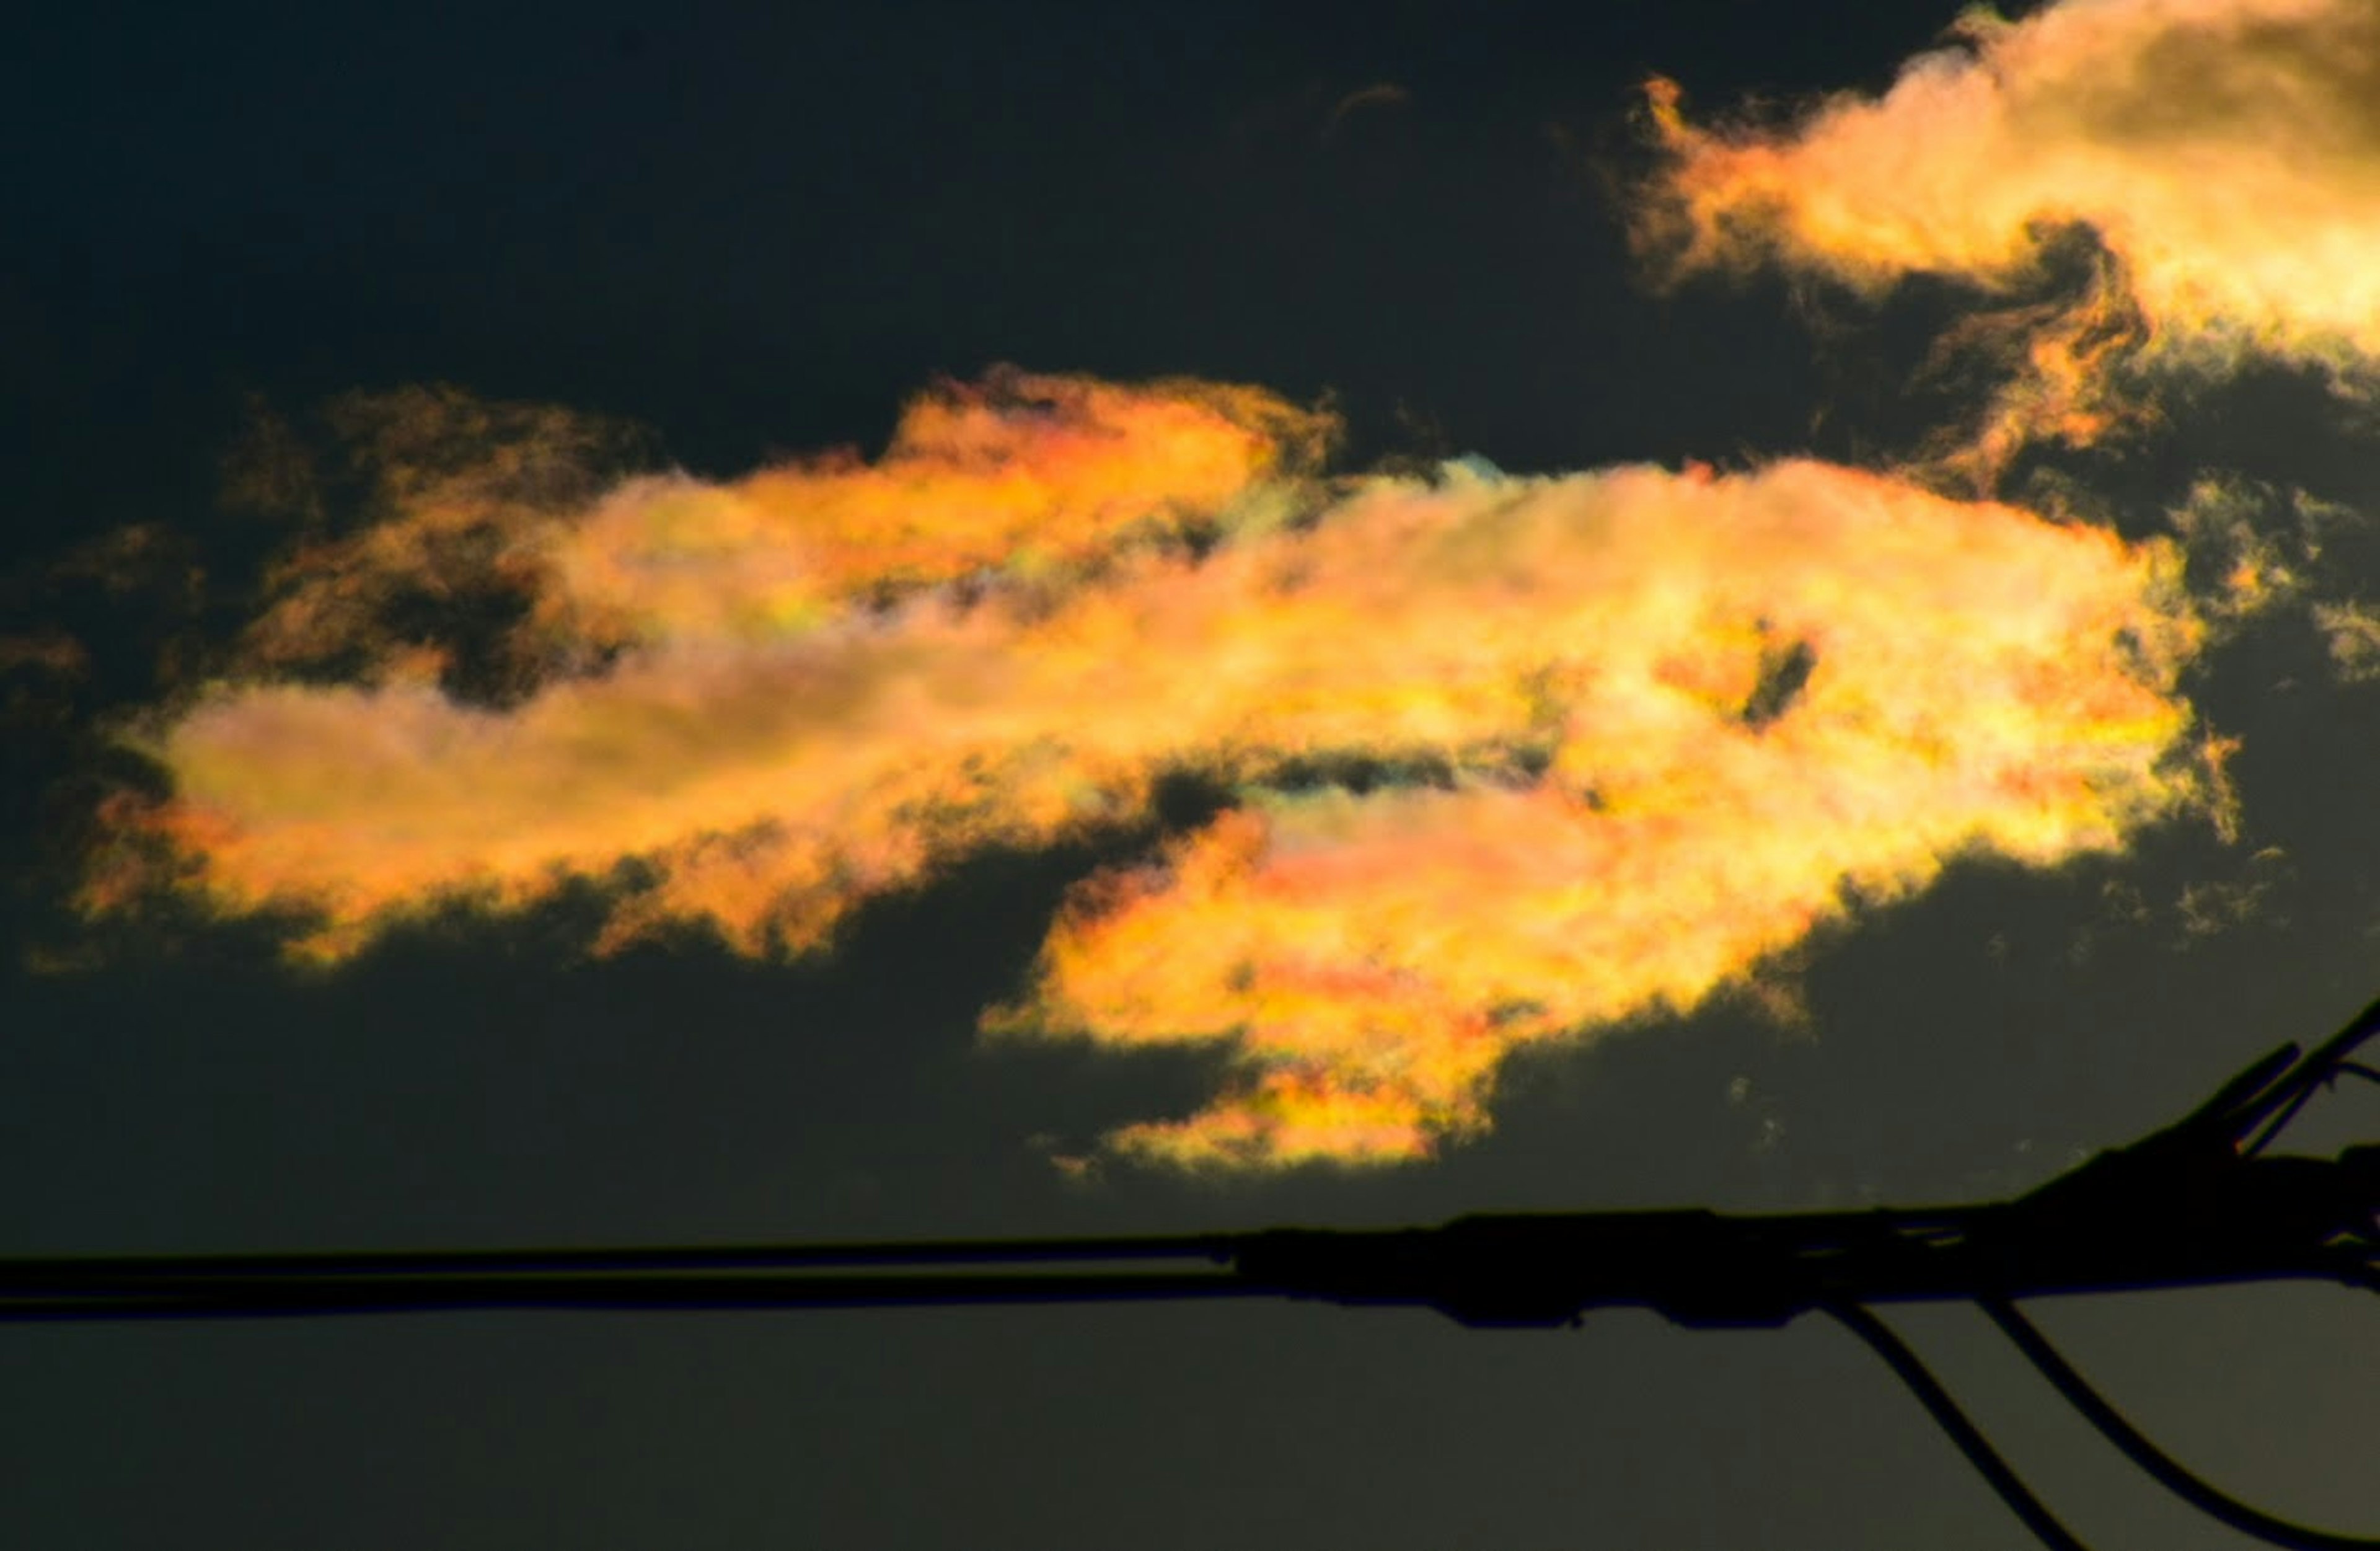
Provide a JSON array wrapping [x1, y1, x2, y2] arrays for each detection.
[[245, 371, 1335, 685]]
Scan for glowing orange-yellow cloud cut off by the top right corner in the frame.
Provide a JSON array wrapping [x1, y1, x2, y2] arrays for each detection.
[[1640, 0, 2380, 454]]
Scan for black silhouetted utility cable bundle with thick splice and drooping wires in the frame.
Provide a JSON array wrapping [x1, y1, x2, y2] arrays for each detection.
[[0, 1002, 2380, 1551]]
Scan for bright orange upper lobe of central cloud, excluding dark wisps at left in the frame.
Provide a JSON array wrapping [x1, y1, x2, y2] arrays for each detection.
[[543, 373, 1333, 640]]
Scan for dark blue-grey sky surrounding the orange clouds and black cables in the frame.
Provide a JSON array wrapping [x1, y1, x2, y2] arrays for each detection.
[[0, 0, 2380, 1551]]
